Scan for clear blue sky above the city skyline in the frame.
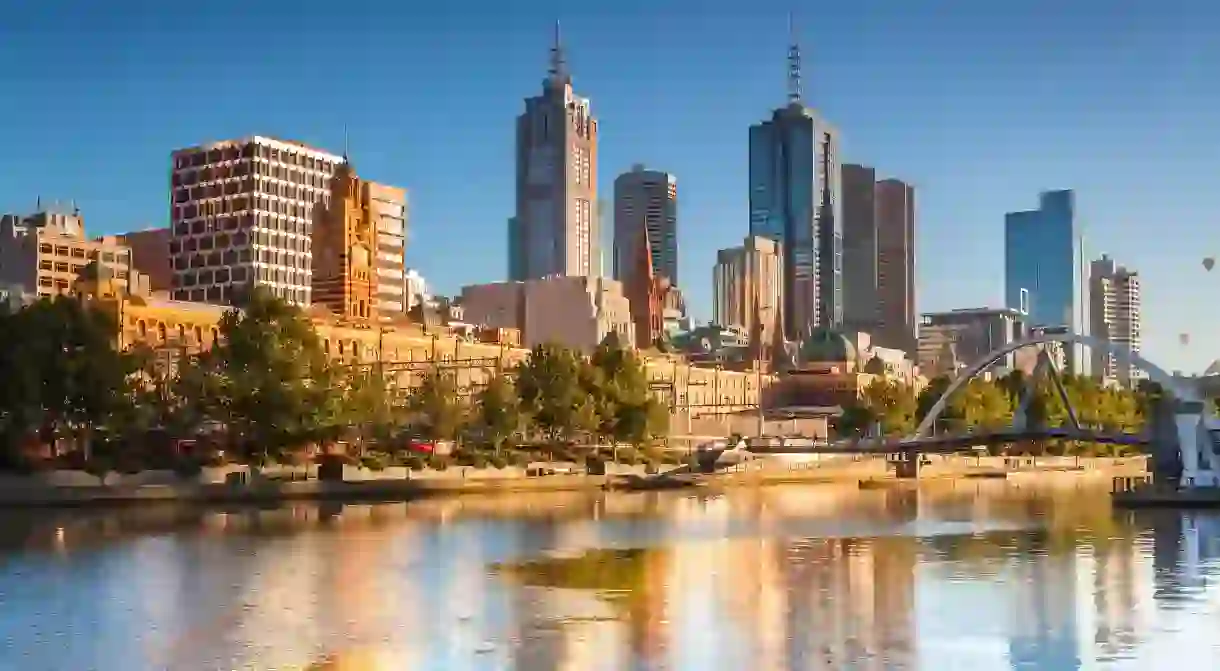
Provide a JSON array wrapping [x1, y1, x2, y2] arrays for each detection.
[[0, 0, 1220, 368]]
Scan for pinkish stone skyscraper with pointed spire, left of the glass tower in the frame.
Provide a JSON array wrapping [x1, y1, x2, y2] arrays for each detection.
[[509, 23, 601, 281]]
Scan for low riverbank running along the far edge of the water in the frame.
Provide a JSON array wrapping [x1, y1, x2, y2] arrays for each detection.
[[0, 459, 1151, 508]]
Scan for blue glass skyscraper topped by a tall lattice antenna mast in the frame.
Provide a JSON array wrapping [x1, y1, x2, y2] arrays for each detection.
[[749, 19, 843, 339]]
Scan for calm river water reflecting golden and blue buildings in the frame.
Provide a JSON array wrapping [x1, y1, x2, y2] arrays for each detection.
[[0, 483, 1220, 671]]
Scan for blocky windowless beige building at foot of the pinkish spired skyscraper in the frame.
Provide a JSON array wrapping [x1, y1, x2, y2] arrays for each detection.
[[461, 276, 636, 353]]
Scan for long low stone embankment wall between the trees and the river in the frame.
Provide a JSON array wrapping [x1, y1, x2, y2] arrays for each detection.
[[0, 456, 1147, 508]]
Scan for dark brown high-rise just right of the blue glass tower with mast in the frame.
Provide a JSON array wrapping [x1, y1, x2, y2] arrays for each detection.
[[843, 165, 917, 355]]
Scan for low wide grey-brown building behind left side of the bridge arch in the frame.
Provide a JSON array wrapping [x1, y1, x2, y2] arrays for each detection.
[[916, 307, 1027, 377]]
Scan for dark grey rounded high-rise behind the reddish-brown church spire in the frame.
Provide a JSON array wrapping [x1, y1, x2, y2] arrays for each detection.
[[614, 165, 678, 284]]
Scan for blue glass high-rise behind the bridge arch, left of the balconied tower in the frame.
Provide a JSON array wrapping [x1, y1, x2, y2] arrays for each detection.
[[1004, 190, 1083, 371]]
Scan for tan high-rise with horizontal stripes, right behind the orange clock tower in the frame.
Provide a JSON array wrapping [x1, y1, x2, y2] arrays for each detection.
[[361, 181, 411, 316]]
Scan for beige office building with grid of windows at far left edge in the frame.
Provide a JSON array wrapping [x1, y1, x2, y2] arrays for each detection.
[[0, 211, 140, 296]]
